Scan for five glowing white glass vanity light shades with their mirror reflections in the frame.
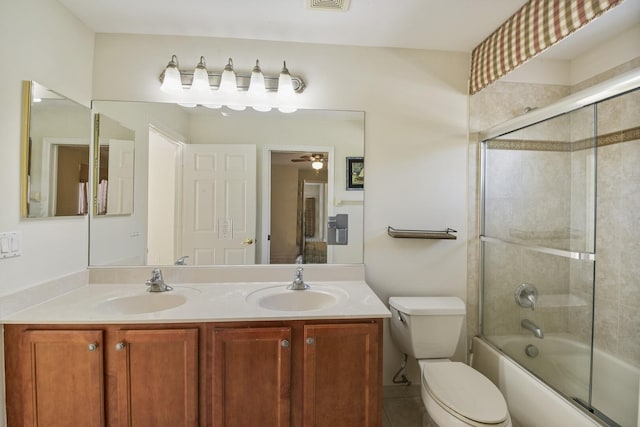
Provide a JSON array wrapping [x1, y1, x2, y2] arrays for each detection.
[[160, 55, 305, 113]]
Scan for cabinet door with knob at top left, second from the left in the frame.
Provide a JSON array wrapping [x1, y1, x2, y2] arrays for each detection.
[[114, 329, 198, 427]]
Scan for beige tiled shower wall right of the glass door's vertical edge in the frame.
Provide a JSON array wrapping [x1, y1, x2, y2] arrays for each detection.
[[594, 90, 640, 367]]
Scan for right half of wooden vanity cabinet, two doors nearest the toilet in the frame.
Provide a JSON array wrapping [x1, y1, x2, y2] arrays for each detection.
[[210, 321, 382, 427]]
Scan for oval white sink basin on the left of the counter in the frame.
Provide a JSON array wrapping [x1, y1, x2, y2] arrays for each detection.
[[100, 288, 200, 314]]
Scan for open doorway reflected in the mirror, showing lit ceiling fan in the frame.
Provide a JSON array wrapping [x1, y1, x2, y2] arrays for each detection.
[[269, 151, 329, 264]]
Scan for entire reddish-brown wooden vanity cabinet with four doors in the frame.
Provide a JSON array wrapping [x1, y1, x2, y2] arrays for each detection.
[[4, 319, 382, 427]]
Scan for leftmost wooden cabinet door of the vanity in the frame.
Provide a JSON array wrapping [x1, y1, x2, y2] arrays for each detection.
[[21, 330, 104, 427]]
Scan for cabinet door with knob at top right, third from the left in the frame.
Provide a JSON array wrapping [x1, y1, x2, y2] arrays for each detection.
[[212, 327, 291, 427]]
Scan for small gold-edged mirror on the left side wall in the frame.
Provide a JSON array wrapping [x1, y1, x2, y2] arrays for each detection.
[[21, 81, 91, 218]]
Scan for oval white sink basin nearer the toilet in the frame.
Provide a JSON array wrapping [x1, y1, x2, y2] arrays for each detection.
[[247, 285, 348, 311]]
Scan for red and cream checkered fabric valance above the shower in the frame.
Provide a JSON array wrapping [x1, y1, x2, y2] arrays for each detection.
[[469, 0, 623, 95]]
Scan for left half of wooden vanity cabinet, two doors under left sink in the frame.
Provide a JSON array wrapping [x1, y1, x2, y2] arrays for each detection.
[[4, 325, 199, 427]]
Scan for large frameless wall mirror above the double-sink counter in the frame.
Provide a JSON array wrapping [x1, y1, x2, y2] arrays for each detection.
[[90, 101, 364, 266]]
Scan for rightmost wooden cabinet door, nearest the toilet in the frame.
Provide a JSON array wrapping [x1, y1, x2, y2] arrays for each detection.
[[302, 323, 382, 427]]
